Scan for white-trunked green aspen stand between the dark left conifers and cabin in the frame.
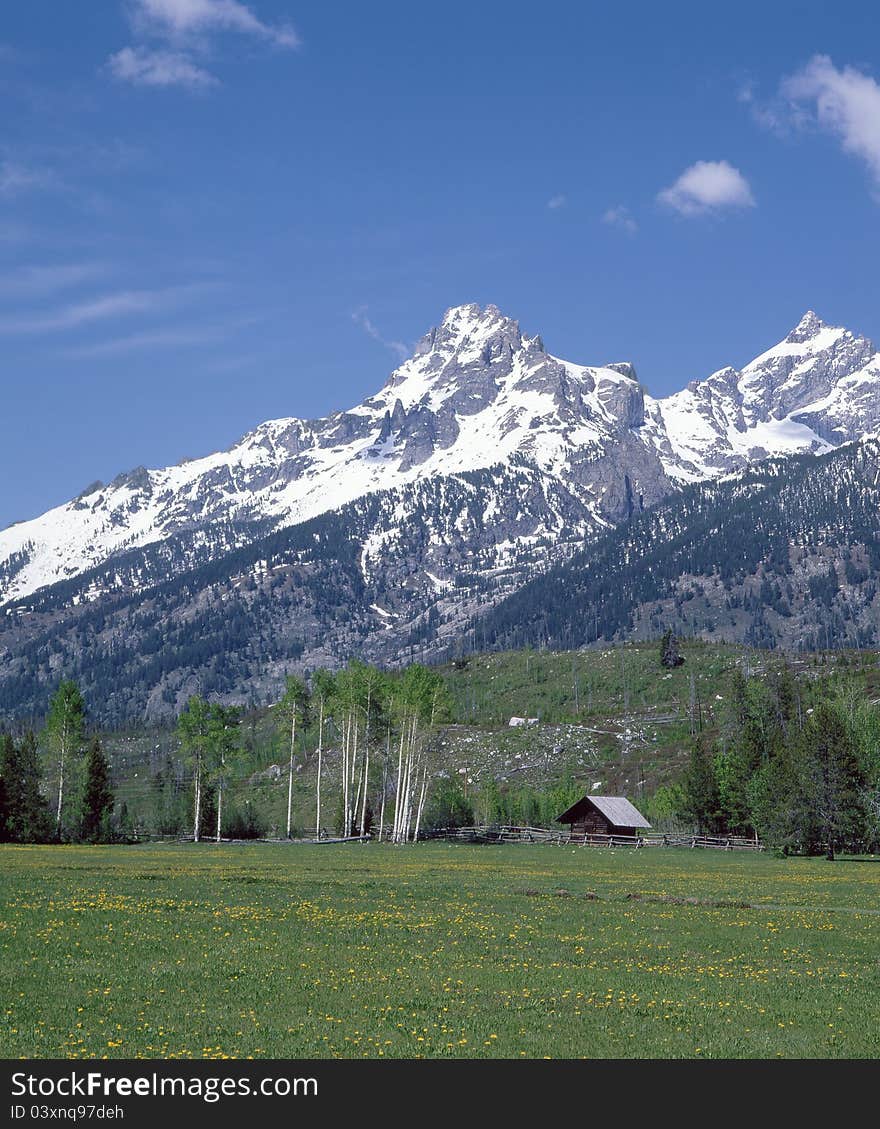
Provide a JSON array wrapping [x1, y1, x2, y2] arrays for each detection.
[[176, 659, 448, 842]]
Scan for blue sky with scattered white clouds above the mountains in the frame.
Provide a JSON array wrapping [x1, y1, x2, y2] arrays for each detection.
[[0, 0, 880, 526]]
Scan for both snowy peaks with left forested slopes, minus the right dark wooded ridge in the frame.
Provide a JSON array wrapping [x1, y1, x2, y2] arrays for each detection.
[[0, 305, 880, 717]]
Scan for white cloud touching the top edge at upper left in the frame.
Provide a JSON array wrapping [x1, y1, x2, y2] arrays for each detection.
[[107, 0, 302, 90]]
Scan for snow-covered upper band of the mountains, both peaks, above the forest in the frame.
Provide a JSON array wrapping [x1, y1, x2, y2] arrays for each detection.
[[0, 305, 880, 605]]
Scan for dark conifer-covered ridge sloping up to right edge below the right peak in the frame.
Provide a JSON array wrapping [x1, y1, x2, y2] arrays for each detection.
[[480, 440, 880, 651]]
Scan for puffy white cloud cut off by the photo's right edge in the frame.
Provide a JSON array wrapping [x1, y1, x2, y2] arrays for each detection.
[[781, 55, 880, 184]]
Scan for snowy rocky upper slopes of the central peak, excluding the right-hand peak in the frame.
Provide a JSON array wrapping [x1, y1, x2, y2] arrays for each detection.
[[0, 306, 672, 603]]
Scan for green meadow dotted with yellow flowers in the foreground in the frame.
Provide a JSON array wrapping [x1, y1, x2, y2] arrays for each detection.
[[0, 844, 880, 1058]]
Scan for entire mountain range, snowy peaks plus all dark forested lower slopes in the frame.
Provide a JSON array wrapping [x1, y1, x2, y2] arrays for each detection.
[[0, 305, 880, 724]]
